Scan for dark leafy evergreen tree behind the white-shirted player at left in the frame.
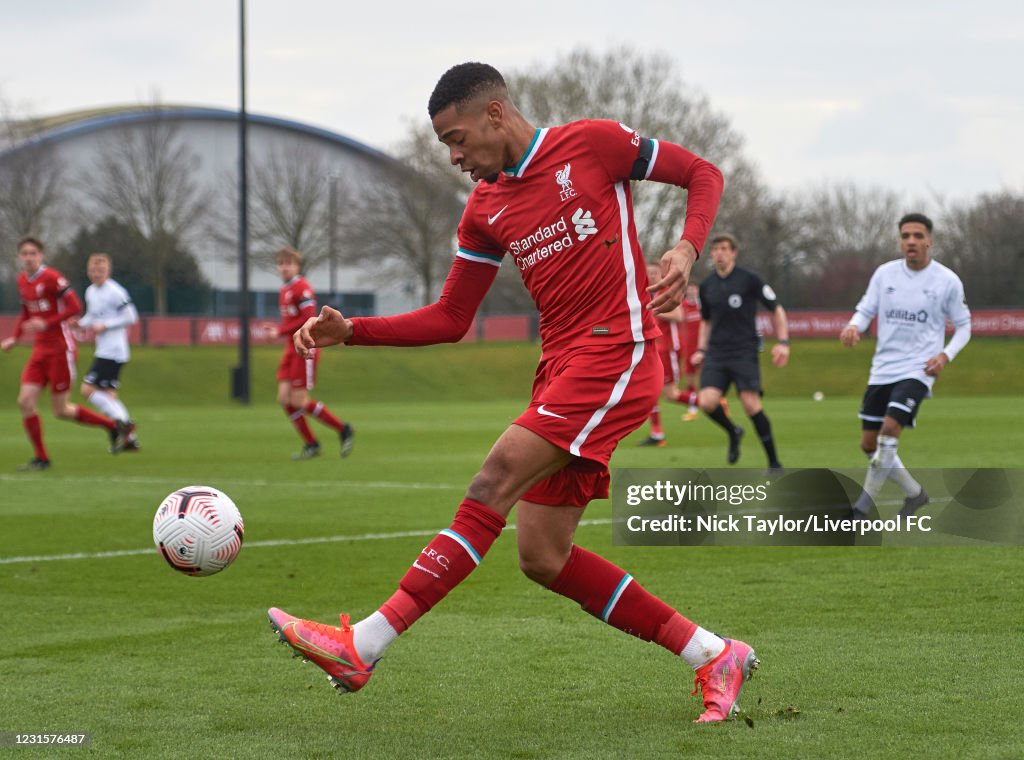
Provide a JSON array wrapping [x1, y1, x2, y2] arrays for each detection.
[[53, 216, 210, 313]]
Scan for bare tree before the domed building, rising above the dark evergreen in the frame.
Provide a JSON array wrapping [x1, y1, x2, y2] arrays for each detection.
[[90, 105, 208, 314]]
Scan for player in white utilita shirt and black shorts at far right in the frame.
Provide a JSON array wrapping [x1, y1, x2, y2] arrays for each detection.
[[840, 214, 971, 517]]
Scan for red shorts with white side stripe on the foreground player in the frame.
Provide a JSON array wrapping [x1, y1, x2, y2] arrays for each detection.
[[515, 340, 663, 507]]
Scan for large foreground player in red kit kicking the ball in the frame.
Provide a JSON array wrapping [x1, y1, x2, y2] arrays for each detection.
[[269, 64, 758, 722]]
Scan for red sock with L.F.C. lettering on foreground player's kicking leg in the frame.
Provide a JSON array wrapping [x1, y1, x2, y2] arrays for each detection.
[[380, 499, 505, 633]]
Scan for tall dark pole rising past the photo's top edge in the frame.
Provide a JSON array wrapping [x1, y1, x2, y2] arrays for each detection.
[[231, 0, 250, 404]]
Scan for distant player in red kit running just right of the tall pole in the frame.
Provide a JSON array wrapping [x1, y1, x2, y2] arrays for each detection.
[[275, 248, 354, 459]]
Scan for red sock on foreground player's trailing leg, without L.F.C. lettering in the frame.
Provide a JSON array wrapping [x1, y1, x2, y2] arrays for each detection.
[[551, 545, 696, 655]]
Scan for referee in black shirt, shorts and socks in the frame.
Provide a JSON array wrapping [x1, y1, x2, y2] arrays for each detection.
[[692, 235, 790, 473]]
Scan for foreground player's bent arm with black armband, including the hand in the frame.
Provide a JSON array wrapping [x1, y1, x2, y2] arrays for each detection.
[[588, 121, 723, 313]]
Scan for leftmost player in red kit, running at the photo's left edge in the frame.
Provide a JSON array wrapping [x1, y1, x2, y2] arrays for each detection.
[[0, 237, 121, 470]]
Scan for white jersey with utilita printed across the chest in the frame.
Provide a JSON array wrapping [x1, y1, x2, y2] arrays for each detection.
[[853, 259, 971, 388]]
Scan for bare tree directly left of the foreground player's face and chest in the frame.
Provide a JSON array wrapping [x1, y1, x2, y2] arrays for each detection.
[[344, 124, 469, 303]]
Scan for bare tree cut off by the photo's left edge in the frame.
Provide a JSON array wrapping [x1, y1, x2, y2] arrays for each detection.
[[0, 98, 66, 279]]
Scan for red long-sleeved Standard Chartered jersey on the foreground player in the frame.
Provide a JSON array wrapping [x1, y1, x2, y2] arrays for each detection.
[[349, 121, 722, 355]]
